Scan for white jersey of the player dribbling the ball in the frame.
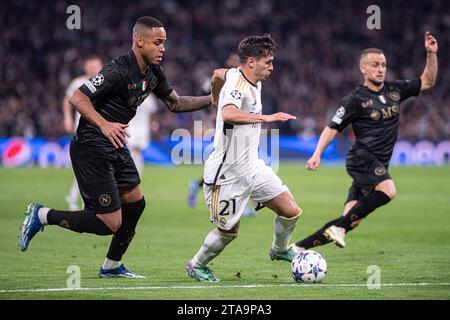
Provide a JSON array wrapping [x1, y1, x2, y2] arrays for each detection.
[[203, 68, 264, 185]]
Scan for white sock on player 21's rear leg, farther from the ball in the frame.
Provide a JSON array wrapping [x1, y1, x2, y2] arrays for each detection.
[[191, 228, 237, 267]]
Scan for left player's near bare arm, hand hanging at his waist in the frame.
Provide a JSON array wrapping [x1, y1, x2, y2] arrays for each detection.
[[69, 89, 130, 148]]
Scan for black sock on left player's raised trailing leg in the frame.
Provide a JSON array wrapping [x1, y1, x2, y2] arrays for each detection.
[[47, 209, 113, 236]]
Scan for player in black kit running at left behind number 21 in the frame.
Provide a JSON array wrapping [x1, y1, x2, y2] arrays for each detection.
[[19, 17, 217, 278]]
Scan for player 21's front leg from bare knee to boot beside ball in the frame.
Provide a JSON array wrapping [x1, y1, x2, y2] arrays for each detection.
[[264, 190, 302, 261]]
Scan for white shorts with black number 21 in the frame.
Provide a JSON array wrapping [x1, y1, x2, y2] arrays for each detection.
[[203, 165, 289, 230]]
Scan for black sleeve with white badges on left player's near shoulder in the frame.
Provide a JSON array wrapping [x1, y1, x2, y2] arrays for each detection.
[[79, 63, 126, 99]]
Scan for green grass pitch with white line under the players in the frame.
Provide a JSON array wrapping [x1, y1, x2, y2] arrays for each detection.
[[0, 163, 450, 299]]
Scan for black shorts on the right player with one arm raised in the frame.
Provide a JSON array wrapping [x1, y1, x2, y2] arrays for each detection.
[[345, 152, 392, 203]]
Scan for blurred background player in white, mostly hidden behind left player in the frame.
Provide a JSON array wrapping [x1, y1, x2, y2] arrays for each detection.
[[62, 56, 103, 211]]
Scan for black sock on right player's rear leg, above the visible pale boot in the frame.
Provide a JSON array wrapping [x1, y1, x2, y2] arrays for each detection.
[[335, 190, 391, 232]]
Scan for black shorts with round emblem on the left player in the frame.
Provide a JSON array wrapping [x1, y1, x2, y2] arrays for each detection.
[[70, 140, 141, 213]]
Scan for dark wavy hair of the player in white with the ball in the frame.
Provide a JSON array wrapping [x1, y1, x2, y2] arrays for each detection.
[[238, 33, 278, 63]]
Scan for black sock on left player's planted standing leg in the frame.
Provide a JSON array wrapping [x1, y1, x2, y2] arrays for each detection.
[[106, 197, 145, 261]]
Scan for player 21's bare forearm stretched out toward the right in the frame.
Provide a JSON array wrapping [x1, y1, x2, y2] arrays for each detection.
[[222, 104, 297, 124]]
